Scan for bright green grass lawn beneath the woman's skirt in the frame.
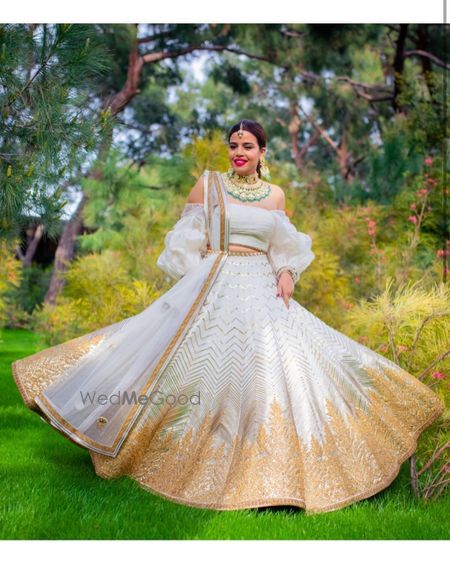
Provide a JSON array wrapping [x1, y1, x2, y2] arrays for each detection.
[[0, 330, 450, 540]]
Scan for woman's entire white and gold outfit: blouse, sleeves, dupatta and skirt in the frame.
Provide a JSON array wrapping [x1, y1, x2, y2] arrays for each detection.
[[13, 171, 444, 512]]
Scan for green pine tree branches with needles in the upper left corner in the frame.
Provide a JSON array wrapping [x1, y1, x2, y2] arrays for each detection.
[[0, 24, 111, 238]]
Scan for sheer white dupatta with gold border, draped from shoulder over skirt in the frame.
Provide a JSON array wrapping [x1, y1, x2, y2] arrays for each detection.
[[12, 170, 229, 457]]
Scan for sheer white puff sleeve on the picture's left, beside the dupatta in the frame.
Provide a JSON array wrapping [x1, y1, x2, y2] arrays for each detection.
[[156, 203, 208, 280]]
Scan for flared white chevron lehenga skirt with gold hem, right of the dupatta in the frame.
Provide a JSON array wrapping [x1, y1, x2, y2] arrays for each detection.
[[83, 253, 444, 512]]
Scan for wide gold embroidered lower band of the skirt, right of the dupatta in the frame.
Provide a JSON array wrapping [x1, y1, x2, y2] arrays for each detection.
[[89, 367, 444, 513]]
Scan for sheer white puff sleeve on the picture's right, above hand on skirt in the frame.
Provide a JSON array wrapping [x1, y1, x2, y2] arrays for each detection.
[[267, 209, 315, 283]]
